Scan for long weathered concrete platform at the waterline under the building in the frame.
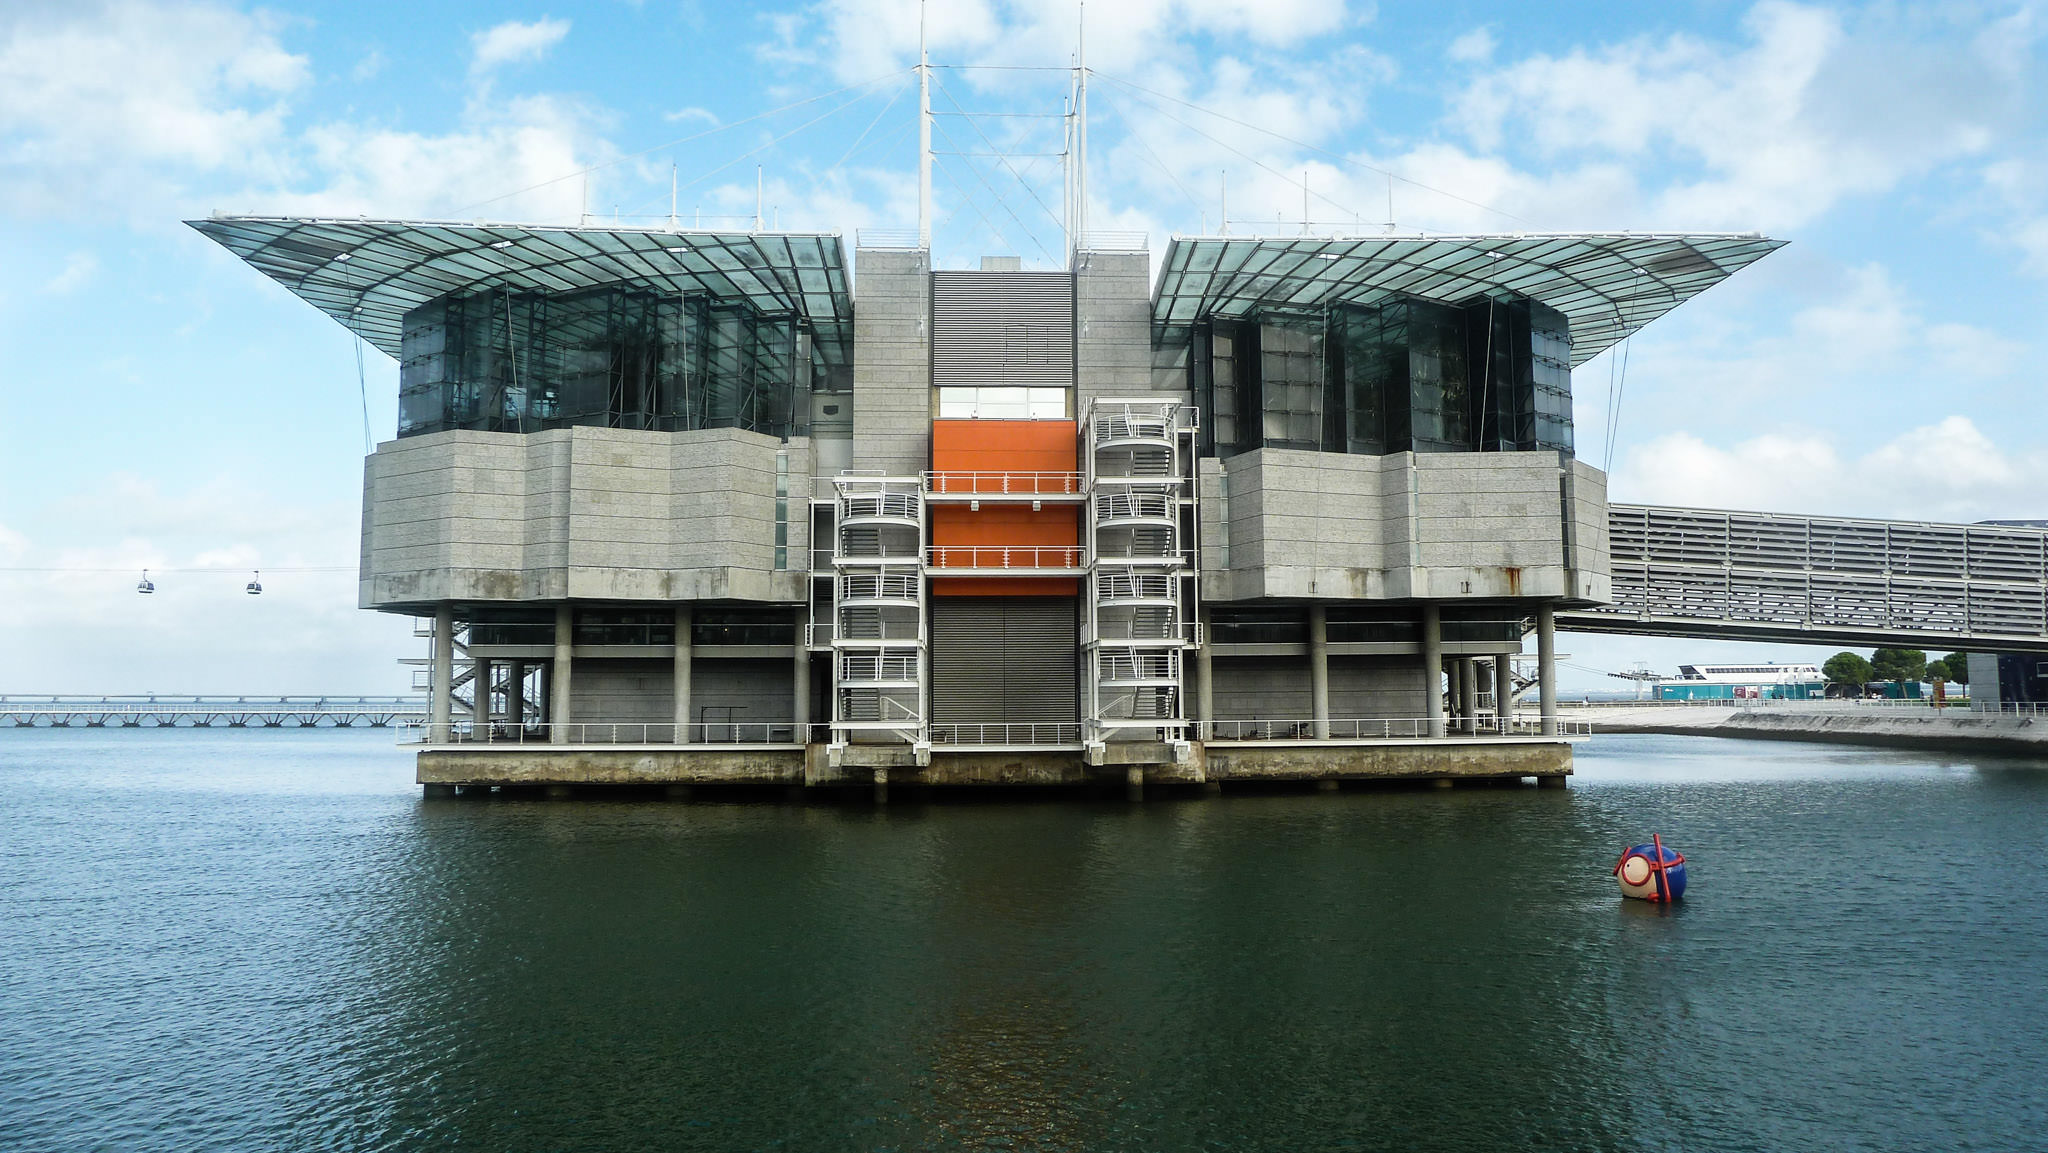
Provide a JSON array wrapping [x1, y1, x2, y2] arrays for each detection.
[[418, 737, 1571, 788]]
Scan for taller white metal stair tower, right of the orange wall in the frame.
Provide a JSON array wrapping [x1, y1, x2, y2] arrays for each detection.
[[1081, 397, 1198, 741]]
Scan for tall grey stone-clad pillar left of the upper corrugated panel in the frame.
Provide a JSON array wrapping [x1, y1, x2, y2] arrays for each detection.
[[854, 248, 932, 477]]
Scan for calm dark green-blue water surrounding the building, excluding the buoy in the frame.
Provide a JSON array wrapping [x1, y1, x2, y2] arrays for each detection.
[[0, 731, 2048, 1151]]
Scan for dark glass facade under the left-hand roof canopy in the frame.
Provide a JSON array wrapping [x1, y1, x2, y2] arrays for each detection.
[[399, 285, 850, 438]]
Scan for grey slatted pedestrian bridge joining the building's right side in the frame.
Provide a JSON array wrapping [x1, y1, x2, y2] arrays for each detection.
[[1556, 504, 2048, 651]]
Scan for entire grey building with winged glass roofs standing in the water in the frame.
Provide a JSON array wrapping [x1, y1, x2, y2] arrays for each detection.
[[195, 217, 1778, 786]]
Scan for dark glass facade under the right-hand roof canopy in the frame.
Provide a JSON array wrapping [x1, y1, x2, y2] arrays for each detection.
[[1187, 293, 1573, 457]]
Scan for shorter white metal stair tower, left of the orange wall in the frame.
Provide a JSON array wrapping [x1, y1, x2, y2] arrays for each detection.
[[831, 475, 930, 745]]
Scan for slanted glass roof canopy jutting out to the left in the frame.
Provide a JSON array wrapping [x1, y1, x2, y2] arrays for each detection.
[[186, 217, 854, 362]]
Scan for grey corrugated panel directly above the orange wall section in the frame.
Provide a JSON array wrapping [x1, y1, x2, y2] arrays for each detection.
[[932, 272, 1073, 387]]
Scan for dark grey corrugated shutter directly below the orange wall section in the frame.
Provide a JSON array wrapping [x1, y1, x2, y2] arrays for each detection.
[[932, 596, 1079, 725]]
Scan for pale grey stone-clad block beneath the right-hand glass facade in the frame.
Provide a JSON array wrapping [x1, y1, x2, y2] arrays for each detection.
[[1200, 449, 1608, 602]]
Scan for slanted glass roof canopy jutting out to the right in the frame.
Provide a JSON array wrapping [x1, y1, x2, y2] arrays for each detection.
[[1153, 231, 1784, 369]]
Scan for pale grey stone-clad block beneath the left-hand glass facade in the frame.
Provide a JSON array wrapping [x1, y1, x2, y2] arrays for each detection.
[[358, 419, 811, 608]]
